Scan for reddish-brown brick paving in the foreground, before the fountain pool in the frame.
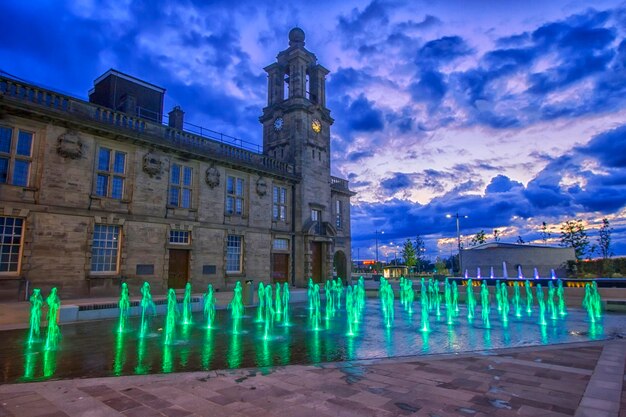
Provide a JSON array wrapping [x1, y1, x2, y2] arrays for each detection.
[[0, 339, 626, 417]]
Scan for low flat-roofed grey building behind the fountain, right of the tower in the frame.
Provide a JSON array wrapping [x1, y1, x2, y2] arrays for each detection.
[[461, 242, 576, 278]]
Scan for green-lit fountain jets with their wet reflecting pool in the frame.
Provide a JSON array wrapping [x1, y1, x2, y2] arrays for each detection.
[[8, 272, 624, 380]]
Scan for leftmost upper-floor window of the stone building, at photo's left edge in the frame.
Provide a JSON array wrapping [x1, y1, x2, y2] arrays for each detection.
[[0, 126, 33, 187]]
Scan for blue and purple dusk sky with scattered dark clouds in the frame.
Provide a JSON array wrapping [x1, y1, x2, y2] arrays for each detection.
[[0, 0, 626, 260]]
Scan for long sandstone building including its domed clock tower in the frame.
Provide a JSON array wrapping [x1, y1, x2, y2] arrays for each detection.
[[0, 28, 353, 297]]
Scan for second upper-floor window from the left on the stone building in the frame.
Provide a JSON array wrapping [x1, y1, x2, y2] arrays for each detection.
[[96, 147, 126, 200]]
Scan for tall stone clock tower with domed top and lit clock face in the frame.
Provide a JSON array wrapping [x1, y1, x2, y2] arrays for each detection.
[[259, 28, 350, 283]]
